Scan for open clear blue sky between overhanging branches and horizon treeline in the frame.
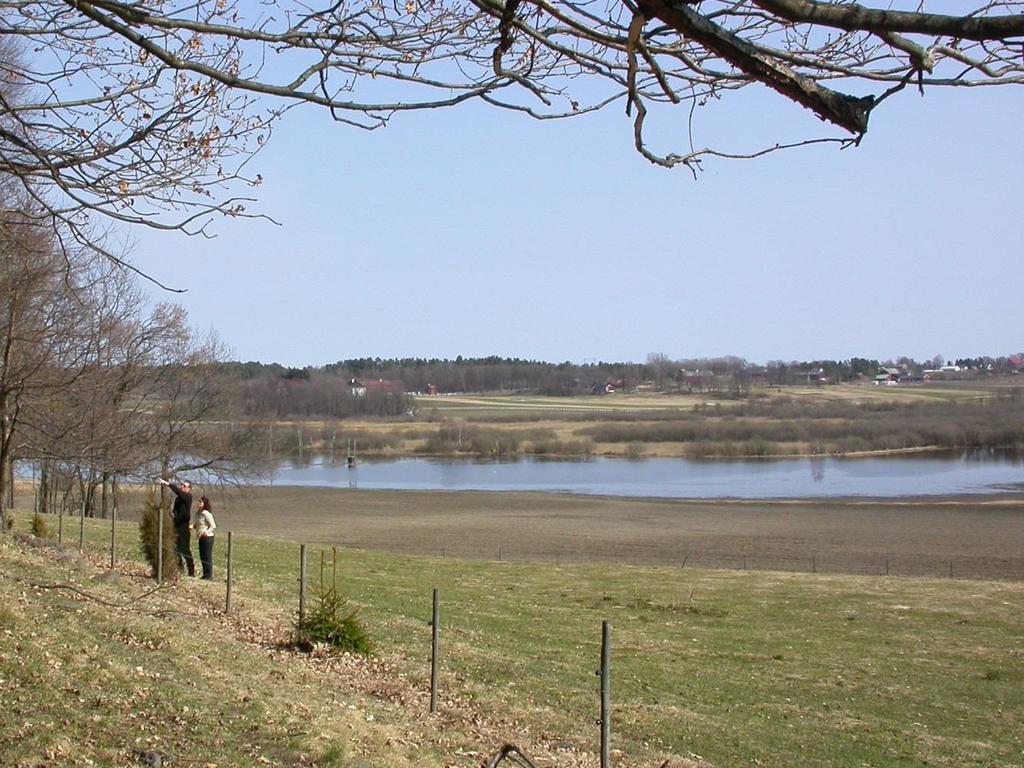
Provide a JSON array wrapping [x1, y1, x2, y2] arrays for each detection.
[[133, 79, 1024, 366]]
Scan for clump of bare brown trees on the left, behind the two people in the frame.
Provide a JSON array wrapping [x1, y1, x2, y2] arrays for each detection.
[[0, 187, 268, 522]]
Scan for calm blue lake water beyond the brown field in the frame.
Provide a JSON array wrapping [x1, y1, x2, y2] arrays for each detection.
[[273, 454, 1024, 499]]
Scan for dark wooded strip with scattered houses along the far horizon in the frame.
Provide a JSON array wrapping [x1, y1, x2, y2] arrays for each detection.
[[219, 354, 1024, 418]]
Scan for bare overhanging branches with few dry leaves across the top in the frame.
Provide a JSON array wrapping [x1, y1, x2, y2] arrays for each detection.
[[0, 0, 1024, 243]]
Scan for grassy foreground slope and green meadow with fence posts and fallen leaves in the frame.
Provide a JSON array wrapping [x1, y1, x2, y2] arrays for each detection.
[[0, 523, 1024, 767]]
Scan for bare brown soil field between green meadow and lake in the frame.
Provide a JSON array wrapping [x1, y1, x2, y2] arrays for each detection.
[[211, 486, 1024, 580]]
